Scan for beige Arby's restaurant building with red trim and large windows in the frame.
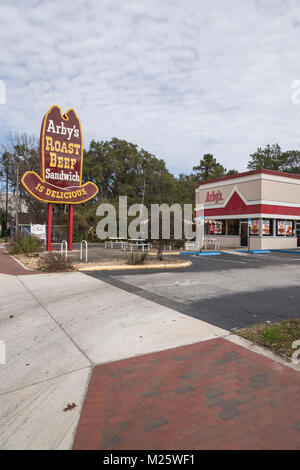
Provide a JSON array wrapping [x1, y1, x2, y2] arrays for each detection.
[[196, 170, 300, 250]]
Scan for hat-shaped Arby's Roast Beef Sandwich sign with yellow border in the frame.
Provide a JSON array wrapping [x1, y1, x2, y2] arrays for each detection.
[[21, 106, 98, 204]]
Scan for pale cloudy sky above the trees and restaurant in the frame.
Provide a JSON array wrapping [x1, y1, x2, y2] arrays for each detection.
[[0, 0, 300, 174]]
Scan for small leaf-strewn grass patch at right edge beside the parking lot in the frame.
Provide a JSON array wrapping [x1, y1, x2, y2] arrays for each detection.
[[236, 318, 300, 359]]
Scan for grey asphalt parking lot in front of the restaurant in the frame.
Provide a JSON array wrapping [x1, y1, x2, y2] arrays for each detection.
[[87, 251, 300, 330]]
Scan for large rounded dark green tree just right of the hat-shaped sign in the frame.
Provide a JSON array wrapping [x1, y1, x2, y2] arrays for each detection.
[[83, 137, 176, 205]]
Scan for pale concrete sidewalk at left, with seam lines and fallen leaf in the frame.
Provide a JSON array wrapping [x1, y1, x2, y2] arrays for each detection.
[[0, 272, 227, 449]]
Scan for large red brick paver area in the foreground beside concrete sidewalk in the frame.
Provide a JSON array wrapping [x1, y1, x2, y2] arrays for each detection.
[[74, 338, 300, 450]]
